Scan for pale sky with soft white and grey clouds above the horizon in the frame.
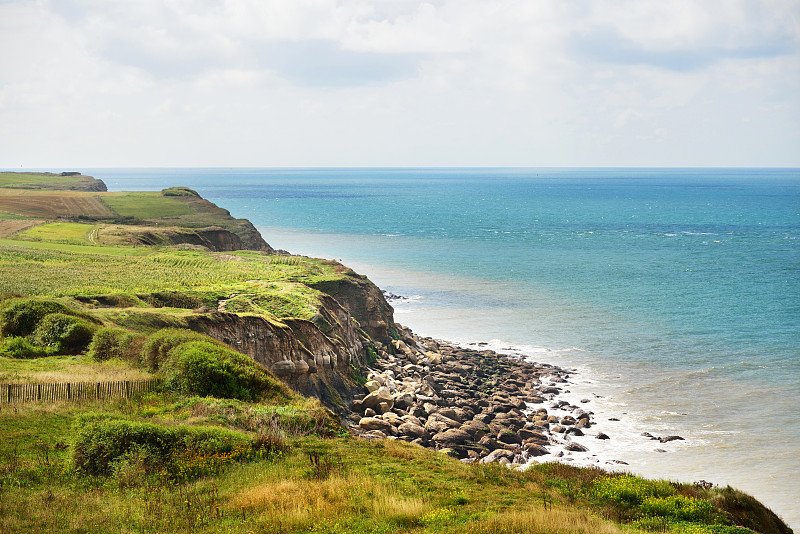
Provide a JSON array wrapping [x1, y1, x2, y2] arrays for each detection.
[[0, 0, 800, 168]]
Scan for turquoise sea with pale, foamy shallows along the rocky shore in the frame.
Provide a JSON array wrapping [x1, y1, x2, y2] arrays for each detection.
[[34, 168, 800, 529]]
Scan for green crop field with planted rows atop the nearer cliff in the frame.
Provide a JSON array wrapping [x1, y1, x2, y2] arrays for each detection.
[[0, 242, 342, 318]]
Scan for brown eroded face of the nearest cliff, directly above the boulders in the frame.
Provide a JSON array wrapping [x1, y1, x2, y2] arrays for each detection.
[[189, 296, 371, 414]]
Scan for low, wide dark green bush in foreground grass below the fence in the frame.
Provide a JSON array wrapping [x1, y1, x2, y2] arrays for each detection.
[[71, 414, 253, 475]]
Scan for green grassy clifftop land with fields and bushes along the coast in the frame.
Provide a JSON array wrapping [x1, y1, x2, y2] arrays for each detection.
[[0, 174, 791, 534]]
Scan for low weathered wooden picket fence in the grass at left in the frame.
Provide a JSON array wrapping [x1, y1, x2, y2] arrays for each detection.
[[0, 378, 161, 404]]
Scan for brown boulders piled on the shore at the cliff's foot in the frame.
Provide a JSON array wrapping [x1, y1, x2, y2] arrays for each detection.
[[350, 325, 682, 465]]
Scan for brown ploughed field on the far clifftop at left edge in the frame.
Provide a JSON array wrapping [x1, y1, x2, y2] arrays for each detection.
[[0, 189, 115, 219]]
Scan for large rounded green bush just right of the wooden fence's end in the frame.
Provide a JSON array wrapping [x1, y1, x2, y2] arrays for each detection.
[[163, 340, 288, 401]]
